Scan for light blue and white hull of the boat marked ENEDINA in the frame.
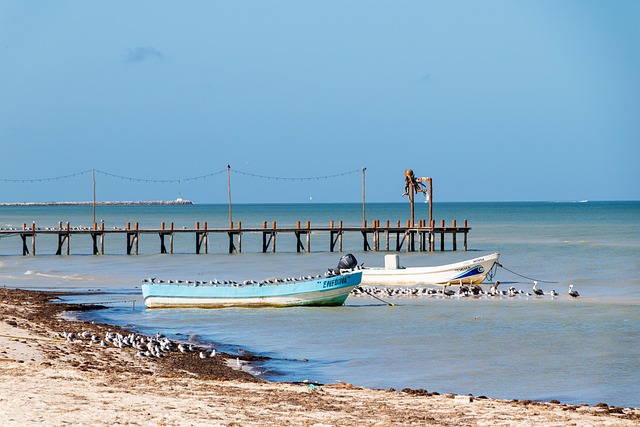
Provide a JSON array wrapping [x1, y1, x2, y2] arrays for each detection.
[[142, 271, 362, 308]]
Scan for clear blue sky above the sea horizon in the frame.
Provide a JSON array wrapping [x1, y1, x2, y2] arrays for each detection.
[[0, 0, 640, 203]]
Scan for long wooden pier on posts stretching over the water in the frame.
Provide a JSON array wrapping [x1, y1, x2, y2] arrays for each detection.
[[0, 220, 471, 256]]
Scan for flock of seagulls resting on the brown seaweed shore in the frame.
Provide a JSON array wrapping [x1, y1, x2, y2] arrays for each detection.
[[54, 331, 216, 359]]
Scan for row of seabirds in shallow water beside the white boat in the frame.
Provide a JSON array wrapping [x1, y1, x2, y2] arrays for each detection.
[[351, 280, 580, 298]]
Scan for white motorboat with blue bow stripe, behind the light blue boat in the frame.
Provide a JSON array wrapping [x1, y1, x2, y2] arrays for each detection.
[[361, 252, 500, 286]]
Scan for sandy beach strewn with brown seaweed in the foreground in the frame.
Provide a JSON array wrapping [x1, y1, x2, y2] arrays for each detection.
[[0, 289, 640, 426]]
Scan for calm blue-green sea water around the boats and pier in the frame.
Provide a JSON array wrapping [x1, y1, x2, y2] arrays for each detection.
[[0, 202, 640, 407]]
